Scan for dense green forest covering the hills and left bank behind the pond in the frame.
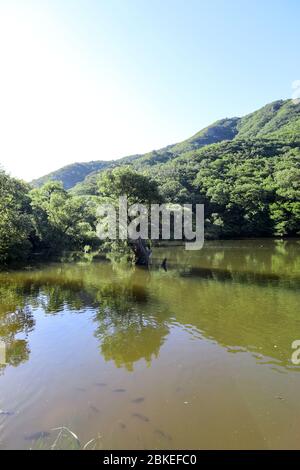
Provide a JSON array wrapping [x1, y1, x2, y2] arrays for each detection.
[[0, 100, 300, 265]]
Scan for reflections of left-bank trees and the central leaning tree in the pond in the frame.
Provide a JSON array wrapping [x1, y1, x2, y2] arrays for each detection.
[[0, 266, 168, 371]]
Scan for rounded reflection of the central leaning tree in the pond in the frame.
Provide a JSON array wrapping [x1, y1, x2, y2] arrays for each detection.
[[95, 280, 169, 371]]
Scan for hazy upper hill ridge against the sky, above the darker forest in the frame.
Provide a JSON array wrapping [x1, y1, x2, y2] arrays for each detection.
[[32, 100, 300, 190]]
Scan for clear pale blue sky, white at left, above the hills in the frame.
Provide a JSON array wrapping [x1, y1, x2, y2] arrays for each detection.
[[0, 0, 300, 179]]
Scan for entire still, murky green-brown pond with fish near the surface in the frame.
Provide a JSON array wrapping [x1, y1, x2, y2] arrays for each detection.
[[0, 240, 300, 449]]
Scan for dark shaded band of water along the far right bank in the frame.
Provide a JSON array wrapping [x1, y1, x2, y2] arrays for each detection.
[[156, 240, 300, 289]]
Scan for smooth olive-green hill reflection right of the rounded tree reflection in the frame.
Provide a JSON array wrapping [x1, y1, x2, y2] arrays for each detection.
[[157, 279, 300, 368]]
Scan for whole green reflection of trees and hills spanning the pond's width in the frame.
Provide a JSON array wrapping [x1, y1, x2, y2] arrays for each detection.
[[0, 240, 300, 371]]
